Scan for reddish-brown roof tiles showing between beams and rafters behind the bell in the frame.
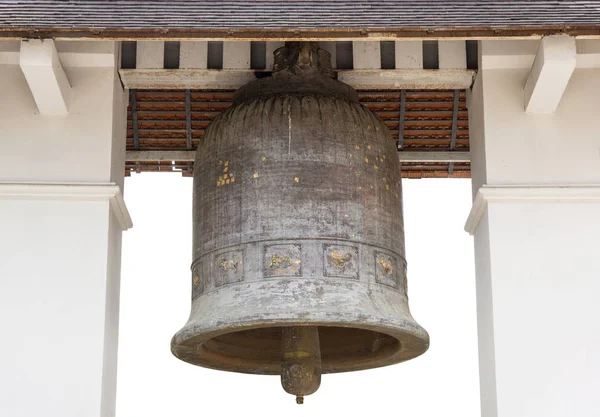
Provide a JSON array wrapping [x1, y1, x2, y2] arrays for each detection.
[[126, 90, 470, 178]]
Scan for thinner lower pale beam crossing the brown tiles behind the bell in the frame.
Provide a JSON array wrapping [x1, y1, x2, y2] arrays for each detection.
[[126, 151, 471, 163]]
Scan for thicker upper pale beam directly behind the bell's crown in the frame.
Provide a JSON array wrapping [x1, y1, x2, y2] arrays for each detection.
[[119, 69, 475, 90]]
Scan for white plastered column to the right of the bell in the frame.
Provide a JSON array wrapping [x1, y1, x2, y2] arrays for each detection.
[[466, 41, 600, 417]]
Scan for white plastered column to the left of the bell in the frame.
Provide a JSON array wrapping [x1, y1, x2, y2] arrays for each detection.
[[0, 42, 131, 417]]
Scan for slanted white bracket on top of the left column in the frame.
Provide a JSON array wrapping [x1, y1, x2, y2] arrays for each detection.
[[19, 39, 71, 116]]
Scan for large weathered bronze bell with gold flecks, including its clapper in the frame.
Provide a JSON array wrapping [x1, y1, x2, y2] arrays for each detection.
[[171, 42, 429, 403]]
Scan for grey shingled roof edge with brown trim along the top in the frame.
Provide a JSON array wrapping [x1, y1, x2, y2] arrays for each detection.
[[0, 0, 600, 39]]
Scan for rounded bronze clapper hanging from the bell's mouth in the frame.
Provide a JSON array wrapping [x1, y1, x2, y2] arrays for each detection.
[[281, 326, 321, 404]]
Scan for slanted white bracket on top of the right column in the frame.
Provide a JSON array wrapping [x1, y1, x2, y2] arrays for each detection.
[[524, 35, 577, 113]]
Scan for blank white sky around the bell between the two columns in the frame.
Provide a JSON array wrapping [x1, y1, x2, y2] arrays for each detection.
[[117, 173, 480, 417]]
